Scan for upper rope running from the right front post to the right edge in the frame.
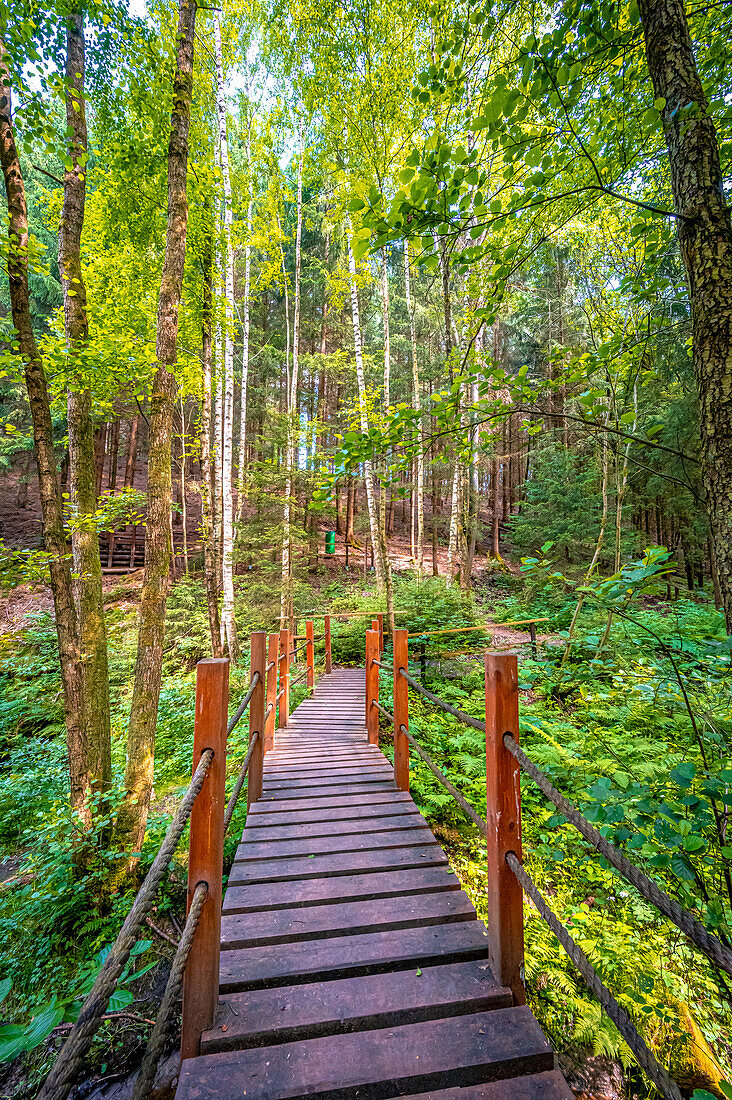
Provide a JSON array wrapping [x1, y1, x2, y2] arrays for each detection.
[[503, 733, 732, 975]]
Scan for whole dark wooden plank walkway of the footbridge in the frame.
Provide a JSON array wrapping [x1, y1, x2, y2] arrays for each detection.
[[176, 670, 572, 1100]]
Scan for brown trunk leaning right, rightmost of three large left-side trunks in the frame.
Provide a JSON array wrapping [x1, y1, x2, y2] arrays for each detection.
[[116, 0, 196, 873]]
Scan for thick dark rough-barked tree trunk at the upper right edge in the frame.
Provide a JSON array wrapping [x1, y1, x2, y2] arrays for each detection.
[[638, 0, 732, 633]]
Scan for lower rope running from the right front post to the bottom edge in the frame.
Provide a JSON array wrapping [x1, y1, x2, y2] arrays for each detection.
[[506, 851, 681, 1100]]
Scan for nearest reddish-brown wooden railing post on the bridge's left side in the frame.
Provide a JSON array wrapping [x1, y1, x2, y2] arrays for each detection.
[[181, 658, 229, 1058]]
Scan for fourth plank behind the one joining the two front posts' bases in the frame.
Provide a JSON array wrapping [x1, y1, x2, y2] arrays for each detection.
[[229, 840, 447, 886]]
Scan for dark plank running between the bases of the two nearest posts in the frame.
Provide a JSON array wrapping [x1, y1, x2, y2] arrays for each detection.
[[200, 961, 511, 1054]]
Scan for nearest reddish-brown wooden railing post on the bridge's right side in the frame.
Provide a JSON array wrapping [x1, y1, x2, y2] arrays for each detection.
[[485, 653, 526, 1004]]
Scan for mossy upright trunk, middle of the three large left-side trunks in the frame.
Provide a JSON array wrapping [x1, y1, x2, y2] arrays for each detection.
[[58, 10, 112, 809]]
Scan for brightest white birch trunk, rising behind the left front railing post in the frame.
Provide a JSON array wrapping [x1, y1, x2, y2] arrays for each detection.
[[214, 12, 239, 661]]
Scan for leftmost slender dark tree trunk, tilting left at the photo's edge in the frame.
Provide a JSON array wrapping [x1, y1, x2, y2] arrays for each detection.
[[0, 32, 89, 823]]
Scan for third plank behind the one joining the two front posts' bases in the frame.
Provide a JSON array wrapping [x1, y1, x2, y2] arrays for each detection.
[[223, 867, 460, 914]]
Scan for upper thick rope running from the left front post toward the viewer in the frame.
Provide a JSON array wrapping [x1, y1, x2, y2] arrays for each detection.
[[37, 749, 214, 1100]]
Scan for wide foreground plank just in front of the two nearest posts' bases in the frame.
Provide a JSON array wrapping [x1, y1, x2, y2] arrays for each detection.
[[177, 1005, 554, 1100]]
